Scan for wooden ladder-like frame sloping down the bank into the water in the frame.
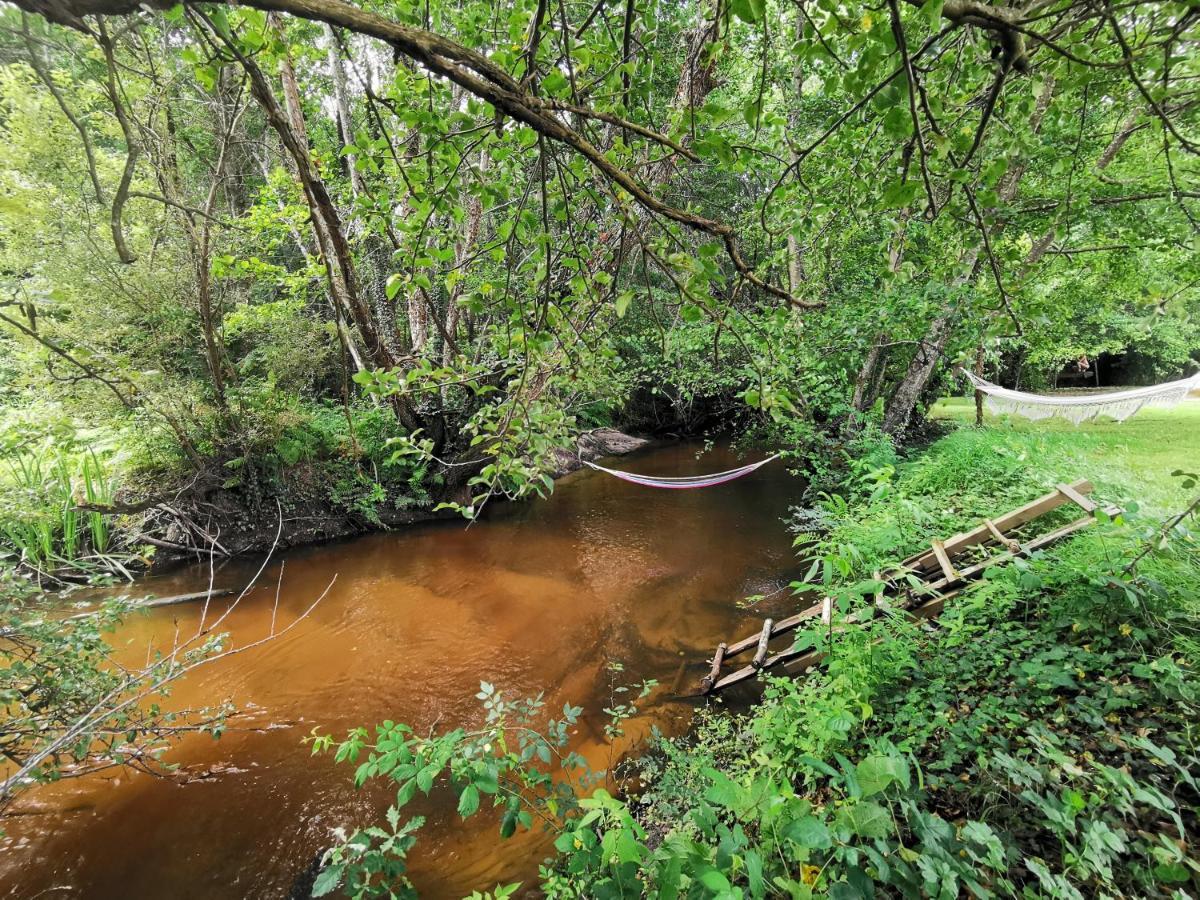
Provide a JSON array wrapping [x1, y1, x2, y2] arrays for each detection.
[[700, 479, 1121, 694]]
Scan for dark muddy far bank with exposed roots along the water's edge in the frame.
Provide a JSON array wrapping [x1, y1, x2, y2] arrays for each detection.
[[126, 428, 649, 570]]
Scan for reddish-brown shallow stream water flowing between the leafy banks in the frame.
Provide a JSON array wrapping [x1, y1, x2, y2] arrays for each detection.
[[0, 444, 802, 900]]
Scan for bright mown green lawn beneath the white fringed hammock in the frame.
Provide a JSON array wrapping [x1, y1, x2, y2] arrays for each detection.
[[930, 397, 1200, 515]]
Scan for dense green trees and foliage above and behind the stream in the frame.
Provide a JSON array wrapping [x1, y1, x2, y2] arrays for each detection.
[[0, 0, 1200, 569]]
